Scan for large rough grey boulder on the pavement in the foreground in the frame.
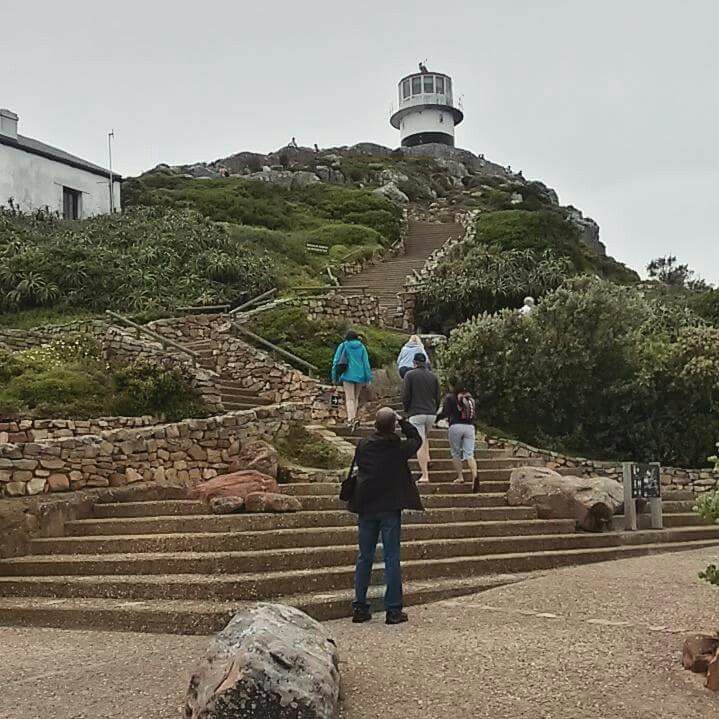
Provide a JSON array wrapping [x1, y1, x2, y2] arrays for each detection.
[[184, 603, 340, 719]]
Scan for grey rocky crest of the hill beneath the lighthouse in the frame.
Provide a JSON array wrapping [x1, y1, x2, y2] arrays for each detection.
[[145, 142, 606, 256]]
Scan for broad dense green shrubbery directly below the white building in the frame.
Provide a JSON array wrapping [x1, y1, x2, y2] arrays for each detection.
[[0, 208, 275, 315]]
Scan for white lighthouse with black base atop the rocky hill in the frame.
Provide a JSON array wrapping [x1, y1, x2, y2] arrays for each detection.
[[389, 63, 464, 147]]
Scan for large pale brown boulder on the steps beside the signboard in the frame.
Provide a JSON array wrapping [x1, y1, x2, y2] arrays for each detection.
[[507, 467, 624, 532]]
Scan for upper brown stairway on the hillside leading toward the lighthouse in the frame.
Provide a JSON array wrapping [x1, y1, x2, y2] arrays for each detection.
[[344, 220, 464, 322]]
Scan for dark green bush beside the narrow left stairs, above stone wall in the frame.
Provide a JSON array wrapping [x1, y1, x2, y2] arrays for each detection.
[[110, 364, 207, 422]]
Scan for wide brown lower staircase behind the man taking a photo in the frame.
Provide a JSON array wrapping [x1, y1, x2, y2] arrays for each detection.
[[0, 430, 719, 634]]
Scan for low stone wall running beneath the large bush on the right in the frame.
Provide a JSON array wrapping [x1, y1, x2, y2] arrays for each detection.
[[485, 436, 719, 494]]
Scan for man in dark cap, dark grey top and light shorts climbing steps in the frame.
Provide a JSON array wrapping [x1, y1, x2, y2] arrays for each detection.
[[402, 352, 442, 482]]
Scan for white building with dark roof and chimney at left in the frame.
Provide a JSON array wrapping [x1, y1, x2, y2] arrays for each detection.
[[0, 109, 122, 220]]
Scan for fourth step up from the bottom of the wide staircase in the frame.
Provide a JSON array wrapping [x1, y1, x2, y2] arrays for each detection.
[[31, 519, 574, 555]]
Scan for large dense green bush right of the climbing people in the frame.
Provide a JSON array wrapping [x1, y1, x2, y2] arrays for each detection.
[[441, 277, 719, 466]]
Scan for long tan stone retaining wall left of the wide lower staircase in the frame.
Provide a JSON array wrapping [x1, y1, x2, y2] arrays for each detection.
[[0, 403, 310, 497]]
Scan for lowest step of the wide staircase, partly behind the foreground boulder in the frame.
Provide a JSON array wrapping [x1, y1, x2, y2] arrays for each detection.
[[0, 574, 524, 635]]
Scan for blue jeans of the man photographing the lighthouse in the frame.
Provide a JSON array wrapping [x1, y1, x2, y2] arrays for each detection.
[[352, 511, 402, 611]]
